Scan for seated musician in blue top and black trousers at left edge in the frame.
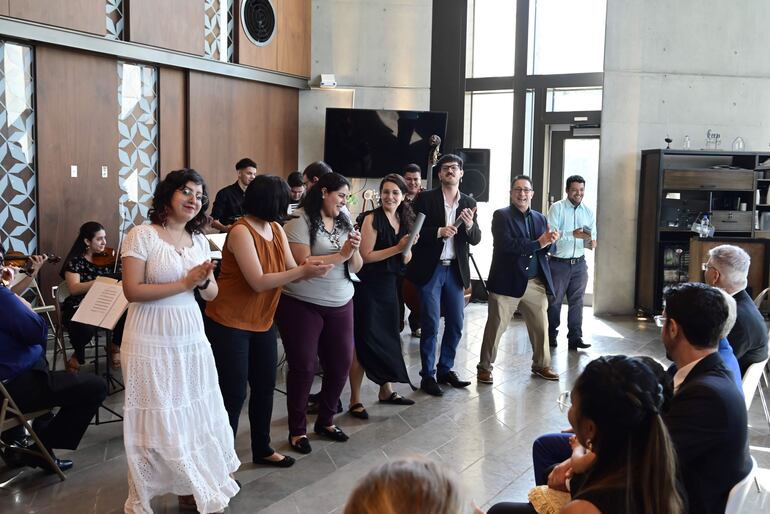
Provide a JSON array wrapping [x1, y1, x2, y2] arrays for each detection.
[[0, 266, 107, 471]]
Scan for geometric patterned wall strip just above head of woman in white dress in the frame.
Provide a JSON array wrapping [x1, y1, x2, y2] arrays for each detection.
[[118, 62, 158, 232]]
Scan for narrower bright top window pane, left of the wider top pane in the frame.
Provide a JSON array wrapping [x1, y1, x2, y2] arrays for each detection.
[[465, 0, 516, 78]]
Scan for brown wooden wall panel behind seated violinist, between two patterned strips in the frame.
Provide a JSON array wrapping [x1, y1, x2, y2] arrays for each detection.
[[35, 45, 120, 288]]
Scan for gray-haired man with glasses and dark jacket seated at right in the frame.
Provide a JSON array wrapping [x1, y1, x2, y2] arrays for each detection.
[[703, 245, 767, 376]]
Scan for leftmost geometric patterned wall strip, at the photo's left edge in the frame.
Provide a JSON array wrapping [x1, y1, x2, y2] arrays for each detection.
[[0, 41, 37, 254]]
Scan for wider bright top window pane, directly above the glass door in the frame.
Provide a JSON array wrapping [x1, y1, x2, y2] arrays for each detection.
[[527, 0, 607, 75]]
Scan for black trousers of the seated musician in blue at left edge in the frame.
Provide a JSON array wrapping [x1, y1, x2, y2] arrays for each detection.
[[4, 359, 107, 450]]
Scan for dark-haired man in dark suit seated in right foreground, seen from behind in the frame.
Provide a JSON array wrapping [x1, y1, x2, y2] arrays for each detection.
[[661, 283, 751, 514]]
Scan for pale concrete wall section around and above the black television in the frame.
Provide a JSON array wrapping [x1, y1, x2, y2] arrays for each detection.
[[299, 0, 433, 208]]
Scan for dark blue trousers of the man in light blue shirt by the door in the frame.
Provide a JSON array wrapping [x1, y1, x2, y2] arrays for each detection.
[[548, 259, 588, 343]]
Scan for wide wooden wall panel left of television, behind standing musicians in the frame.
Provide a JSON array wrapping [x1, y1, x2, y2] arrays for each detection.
[[188, 72, 299, 197]]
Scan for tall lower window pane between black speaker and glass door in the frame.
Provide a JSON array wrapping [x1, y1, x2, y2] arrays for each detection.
[[464, 91, 513, 278]]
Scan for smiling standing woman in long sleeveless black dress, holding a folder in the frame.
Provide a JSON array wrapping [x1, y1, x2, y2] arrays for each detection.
[[348, 173, 414, 419]]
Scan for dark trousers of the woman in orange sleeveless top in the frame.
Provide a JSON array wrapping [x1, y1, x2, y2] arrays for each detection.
[[206, 319, 278, 460]]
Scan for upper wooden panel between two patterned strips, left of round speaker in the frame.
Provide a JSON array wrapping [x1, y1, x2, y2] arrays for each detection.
[[129, 0, 204, 55]]
